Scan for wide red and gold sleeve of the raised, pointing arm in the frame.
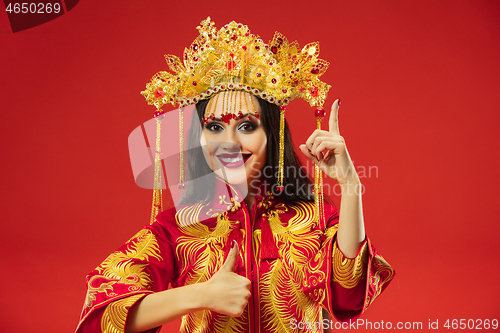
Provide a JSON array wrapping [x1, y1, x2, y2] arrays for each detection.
[[302, 205, 395, 321]]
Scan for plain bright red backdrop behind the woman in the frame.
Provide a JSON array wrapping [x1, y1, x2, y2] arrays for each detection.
[[0, 0, 500, 332]]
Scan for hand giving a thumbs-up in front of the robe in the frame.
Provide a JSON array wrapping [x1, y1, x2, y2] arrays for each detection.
[[204, 242, 252, 317]]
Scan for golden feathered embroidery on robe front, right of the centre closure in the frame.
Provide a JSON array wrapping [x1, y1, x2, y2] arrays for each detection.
[[258, 202, 321, 332]]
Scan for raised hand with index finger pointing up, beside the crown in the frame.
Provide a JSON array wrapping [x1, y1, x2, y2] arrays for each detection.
[[299, 99, 359, 185]]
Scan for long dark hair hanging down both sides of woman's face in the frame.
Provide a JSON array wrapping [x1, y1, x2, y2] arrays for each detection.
[[180, 98, 314, 204]]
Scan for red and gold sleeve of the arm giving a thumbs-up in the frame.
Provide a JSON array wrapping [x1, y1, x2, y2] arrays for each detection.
[[76, 223, 174, 333]]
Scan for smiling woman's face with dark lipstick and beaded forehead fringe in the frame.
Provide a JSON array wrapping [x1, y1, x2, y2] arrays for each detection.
[[200, 92, 267, 185]]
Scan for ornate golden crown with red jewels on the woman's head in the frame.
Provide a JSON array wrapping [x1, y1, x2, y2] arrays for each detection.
[[142, 17, 330, 110]]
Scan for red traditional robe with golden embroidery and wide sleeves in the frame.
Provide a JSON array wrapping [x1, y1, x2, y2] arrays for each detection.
[[77, 180, 394, 333]]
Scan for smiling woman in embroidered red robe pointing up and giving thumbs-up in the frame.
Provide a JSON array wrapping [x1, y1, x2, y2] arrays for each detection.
[[77, 20, 394, 332]]
